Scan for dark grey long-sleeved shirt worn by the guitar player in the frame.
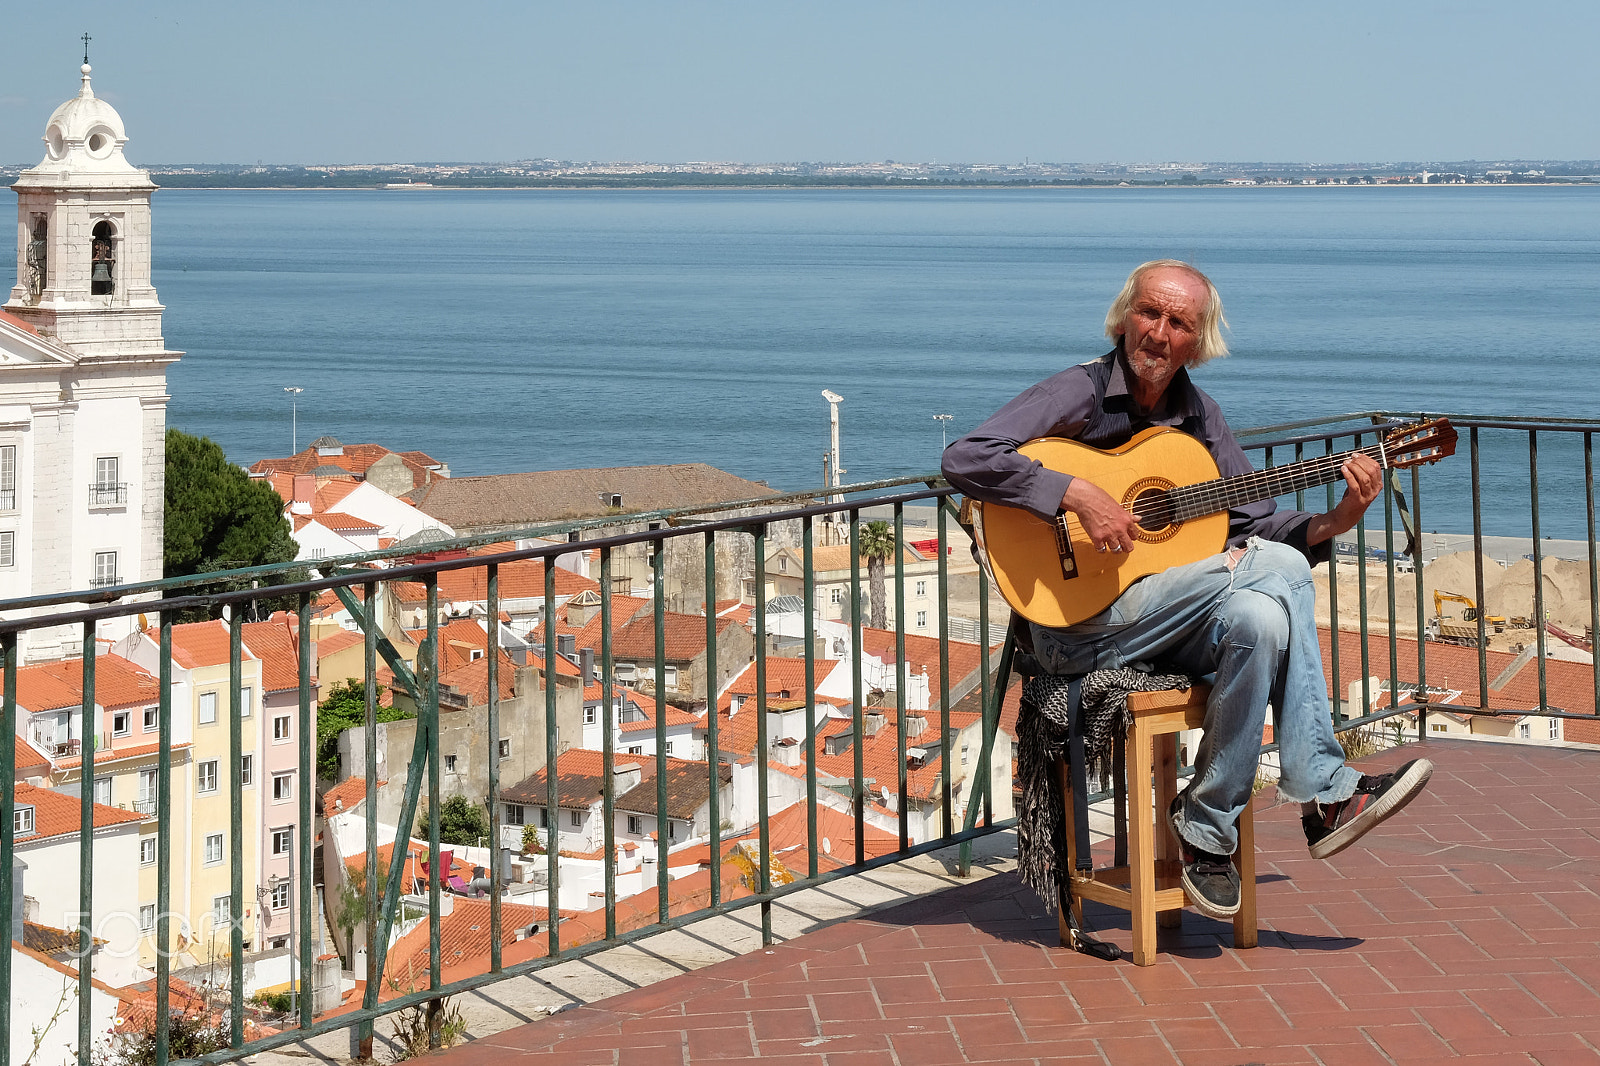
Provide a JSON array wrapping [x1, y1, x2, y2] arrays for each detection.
[[944, 347, 1333, 562]]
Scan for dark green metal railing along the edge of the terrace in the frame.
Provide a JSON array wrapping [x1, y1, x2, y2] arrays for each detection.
[[0, 411, 1600, 1066]]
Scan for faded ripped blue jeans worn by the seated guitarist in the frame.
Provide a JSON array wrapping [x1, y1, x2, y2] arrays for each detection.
[[1034, 538, 1362, 855]]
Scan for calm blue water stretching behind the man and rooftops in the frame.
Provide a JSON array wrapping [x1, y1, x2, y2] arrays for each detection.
[[155, 187, 1600, 536]]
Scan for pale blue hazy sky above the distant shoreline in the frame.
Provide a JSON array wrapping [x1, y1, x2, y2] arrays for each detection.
[[0, 0, 1600, 163]]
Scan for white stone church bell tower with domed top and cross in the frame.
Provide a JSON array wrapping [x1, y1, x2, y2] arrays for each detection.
[[0, 62, 181, 659]]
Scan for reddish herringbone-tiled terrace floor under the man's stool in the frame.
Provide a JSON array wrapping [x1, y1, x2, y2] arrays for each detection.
[[440, 741, 1600, 1066]]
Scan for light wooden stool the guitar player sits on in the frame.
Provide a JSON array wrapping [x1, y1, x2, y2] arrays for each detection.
[[1056, 685, 1256, 967]]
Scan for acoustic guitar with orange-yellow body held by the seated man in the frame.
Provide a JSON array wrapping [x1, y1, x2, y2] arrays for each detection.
[[971, 418, 1456, 627]]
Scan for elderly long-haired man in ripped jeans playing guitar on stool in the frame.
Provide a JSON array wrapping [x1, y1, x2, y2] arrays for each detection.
[[944, 259, 1434, 919]]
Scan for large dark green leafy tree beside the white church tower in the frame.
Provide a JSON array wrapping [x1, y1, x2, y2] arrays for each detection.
[[162, 429, 299, 610]]
